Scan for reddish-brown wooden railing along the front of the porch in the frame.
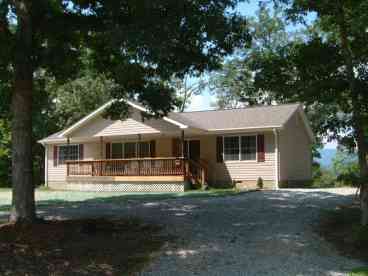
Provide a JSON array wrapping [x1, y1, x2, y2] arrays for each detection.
[[66, 157, 185, 176]]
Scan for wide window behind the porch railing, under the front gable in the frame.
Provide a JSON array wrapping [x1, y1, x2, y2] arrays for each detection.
[[111, 142, 151, 159]]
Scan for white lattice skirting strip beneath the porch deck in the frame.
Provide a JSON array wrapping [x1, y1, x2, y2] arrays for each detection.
[[49, 182, 188, 193]]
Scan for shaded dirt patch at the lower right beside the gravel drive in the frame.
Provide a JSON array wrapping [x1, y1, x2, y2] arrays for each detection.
[[318, 204, 368, 262]]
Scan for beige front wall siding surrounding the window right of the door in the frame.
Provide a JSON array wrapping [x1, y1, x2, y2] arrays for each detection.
[[200, 132, 275, 182]]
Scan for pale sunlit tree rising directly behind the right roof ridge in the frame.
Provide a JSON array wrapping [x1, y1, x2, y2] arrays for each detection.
[[210, 5, 299, 108]]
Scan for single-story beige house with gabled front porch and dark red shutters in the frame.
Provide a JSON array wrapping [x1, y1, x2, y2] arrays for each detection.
[[39, 101, 314, 192]]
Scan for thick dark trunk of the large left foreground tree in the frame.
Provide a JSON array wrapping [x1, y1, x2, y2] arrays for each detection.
[[10, 1, 36, 222]]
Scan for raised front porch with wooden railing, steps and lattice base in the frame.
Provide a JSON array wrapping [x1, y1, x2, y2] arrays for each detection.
[[66, 157, 208, 192]]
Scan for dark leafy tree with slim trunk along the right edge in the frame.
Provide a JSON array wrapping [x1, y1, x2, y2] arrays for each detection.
[[272, 0, 368, 225]]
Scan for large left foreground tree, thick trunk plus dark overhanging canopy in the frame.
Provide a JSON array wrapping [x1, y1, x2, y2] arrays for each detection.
[[0, 0, 248, 222]]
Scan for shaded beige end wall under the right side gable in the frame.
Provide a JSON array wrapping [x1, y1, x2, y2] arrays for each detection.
[[279, 113, 312, 181]]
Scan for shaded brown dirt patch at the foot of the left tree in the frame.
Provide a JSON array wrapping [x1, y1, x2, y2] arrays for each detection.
[[0, 219, 164, 276]]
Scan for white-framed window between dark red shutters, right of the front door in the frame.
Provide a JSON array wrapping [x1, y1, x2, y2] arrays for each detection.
[[224, 135, 257, 161]]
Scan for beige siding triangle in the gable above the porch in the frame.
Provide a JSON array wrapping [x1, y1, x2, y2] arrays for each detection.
[[71, 108, 178, 138]]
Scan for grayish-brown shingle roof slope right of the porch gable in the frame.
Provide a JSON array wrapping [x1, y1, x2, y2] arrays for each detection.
[[169, 103, 300, 130]]
